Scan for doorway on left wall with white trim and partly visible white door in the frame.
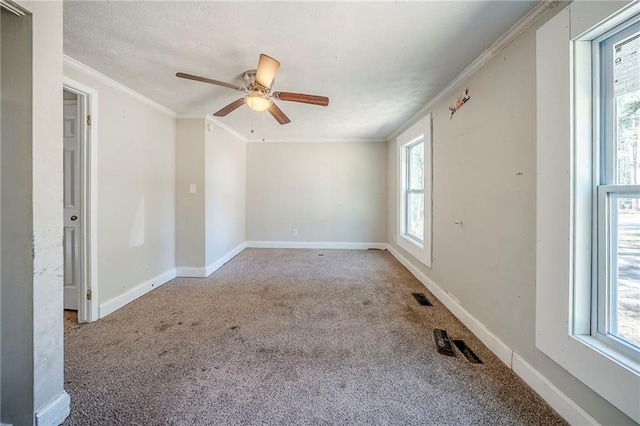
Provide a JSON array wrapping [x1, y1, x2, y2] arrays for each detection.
[[62, 79, 99, 330]]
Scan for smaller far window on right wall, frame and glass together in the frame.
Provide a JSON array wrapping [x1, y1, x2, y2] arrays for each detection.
[[396, 114, 431, 266]]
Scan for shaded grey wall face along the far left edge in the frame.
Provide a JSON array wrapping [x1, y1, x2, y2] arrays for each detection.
[[0, 11, 34, 424]]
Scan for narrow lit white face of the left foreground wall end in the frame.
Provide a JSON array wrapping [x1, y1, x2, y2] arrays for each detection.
[[32, 2, 69, 424]]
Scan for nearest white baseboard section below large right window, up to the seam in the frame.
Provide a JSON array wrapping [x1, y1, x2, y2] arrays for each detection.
[[512, 352, 600, 425]]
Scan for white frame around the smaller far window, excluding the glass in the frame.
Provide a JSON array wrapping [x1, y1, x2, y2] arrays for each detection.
[[396, 114, 433, 267]]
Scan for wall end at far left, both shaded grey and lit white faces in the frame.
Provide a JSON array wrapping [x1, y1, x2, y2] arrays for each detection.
[[1, 2, 69, 424]]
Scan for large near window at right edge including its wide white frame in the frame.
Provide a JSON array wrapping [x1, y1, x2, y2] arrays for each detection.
[[536, 2, 640, 423]]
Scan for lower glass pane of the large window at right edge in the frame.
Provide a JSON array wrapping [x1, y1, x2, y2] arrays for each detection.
[[610, 197, 640, 347]]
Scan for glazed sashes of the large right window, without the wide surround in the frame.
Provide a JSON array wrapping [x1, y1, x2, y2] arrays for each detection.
[[591, 21, 640, 356]]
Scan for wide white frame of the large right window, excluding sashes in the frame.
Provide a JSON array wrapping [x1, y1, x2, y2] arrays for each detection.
[[536, 2, 640, 422]]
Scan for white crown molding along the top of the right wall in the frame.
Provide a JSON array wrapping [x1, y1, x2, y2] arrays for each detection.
[[386, 0, 560, 140]]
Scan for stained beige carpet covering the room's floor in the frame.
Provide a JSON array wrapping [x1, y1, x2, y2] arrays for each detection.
[[65, 249, 564, 425]]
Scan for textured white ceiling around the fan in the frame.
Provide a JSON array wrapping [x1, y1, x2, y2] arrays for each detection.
[[64, 0, 537, 140]]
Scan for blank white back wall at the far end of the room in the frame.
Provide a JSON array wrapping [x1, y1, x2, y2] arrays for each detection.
[[247, 142, 387, 243]]
